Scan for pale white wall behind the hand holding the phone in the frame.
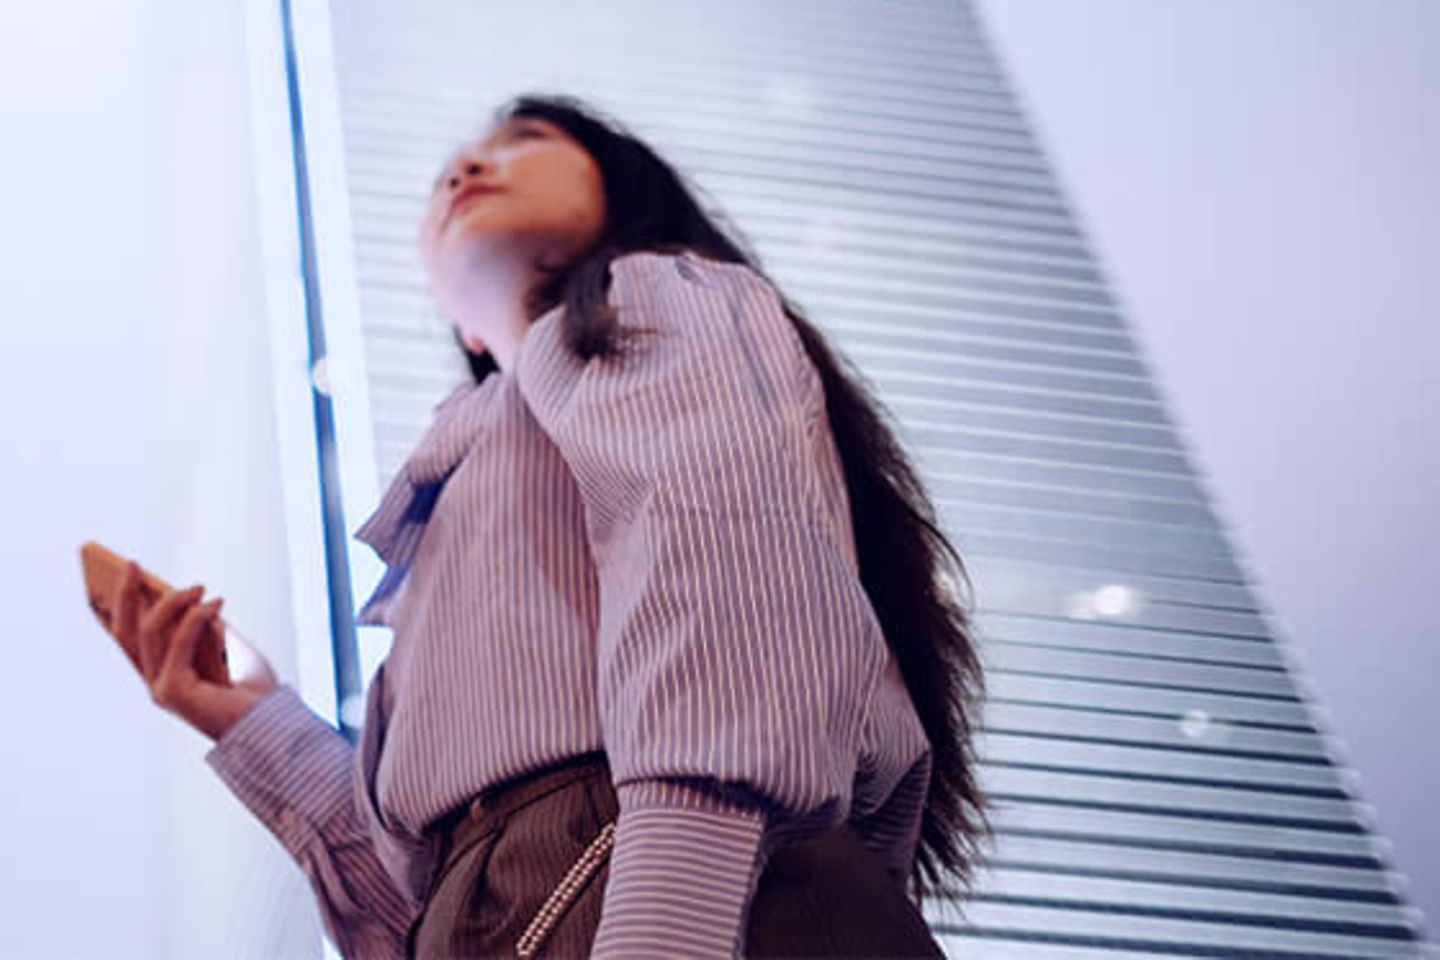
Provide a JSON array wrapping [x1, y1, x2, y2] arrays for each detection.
[[0, 0, 324, 960]]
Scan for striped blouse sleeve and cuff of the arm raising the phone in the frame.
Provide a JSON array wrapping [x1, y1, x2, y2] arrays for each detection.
[[204, 685, 419, 960]]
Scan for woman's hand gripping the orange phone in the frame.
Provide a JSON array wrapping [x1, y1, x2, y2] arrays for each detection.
[[112, 563, 278, 740]]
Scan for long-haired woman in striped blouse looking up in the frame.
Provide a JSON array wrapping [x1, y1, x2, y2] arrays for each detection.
[[117, 96, 988, 957]]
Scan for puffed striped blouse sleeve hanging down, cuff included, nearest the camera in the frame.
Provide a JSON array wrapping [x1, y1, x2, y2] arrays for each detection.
[[506, 253, 884, 957]]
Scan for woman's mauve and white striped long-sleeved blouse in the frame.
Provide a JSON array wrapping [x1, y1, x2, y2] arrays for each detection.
[[206, 252, 930, 957]]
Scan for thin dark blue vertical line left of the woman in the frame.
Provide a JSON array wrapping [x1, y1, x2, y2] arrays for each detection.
[[279, 0, 363, 744]]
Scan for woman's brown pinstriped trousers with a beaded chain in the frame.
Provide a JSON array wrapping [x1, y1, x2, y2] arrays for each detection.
[[408, 754, 945, 960]]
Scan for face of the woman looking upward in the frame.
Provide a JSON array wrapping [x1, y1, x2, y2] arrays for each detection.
[[419, 117, 605, 299]]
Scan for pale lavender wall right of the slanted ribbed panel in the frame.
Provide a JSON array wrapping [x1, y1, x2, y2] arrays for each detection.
[[976, 0, 1440, 936]]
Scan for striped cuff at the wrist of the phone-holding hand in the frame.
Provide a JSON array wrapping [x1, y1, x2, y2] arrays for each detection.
[[204, 684, 354, 855]]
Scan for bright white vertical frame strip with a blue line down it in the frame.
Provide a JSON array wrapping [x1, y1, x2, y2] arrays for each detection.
[[245, 0, 383, 743]]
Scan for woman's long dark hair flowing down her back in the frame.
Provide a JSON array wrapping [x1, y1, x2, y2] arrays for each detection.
[[455, 94, 992, 900]]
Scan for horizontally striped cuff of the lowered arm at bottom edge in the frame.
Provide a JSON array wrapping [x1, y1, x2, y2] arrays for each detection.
[[590, 780, 766, 959]]
